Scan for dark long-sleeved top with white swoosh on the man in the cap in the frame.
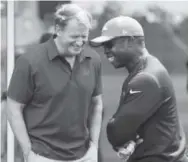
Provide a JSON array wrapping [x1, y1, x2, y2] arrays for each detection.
[[107, 56, 188, 162]]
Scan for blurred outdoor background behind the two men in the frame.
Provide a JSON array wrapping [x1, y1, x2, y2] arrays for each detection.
[[0, 0, 188, 162]]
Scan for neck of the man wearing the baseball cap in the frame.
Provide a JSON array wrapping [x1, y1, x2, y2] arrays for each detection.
[[126, 48, 149, 73]]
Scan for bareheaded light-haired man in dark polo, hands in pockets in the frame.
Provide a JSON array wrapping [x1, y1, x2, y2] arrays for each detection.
[[7, 4, 103, 162]]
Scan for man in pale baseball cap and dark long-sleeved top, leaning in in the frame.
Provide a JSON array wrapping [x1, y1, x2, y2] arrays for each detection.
[[90, 16, 188, 162]]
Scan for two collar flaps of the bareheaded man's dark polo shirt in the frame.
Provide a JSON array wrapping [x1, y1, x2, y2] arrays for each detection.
[[46, 37, 93, 61]]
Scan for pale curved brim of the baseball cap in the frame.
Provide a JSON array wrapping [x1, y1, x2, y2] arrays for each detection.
[[89, 36, 114, 47]]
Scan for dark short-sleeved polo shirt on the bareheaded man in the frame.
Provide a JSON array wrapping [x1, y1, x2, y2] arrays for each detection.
[[8, 38, 102, 160]]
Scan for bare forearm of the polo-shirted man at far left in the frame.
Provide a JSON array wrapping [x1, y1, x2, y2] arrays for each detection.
[[7, 97, 31, 157]]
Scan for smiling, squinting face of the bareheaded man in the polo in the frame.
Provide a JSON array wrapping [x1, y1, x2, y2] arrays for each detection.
[[59, 19, 89, 56]]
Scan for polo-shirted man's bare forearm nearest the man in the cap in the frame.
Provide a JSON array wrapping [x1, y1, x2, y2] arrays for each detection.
[[90, 95, 103, 146]]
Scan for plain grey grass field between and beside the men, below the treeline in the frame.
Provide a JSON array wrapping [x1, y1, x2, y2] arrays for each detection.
[[101, 75, 188, 162]]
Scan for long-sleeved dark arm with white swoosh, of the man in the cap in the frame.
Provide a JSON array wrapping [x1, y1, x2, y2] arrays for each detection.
[[107, 75, 160, 150]]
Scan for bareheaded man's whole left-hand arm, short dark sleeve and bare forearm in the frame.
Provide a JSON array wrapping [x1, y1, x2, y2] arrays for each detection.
[[7, 56, 34, 157]]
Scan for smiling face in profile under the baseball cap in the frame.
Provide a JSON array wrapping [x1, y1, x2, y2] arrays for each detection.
[[103, 37, 132, 68]]
